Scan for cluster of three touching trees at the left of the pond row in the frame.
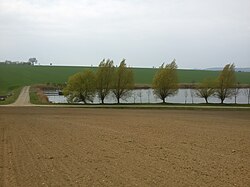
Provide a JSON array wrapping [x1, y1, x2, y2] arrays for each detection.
[[64, 59, 134, 104]]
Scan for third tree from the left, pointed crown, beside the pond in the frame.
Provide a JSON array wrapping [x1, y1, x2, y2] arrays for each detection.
[[112, 59, 134, 104]]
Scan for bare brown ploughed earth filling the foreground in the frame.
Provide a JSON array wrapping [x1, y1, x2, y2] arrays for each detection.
[[0, 107, 250, 187]]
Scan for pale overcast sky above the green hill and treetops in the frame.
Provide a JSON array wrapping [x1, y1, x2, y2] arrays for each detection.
[[0, 0, 250, 68]]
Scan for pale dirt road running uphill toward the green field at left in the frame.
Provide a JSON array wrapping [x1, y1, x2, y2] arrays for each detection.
[[9, 86, 32, 106]]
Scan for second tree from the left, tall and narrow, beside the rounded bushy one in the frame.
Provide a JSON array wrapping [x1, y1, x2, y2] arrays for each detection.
[[96, 59, 115, 104]]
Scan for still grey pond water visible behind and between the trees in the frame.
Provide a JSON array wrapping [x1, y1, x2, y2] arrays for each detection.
[[46, 89, 248, 104]]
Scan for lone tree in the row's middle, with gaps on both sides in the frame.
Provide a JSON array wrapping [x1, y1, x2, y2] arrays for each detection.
[[152, 60, 178, 103]]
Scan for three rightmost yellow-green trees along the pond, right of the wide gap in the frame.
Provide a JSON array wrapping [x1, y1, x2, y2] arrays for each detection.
[[152, 60, 239, 104]]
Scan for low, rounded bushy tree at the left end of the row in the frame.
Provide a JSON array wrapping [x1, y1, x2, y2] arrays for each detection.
[[64, 70, 96, 104]]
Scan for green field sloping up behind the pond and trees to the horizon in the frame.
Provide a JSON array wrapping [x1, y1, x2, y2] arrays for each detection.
[[0, 64, 250, 94]]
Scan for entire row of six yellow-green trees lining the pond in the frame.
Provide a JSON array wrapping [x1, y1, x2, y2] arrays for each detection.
[[64, 59, 245, 104]]
